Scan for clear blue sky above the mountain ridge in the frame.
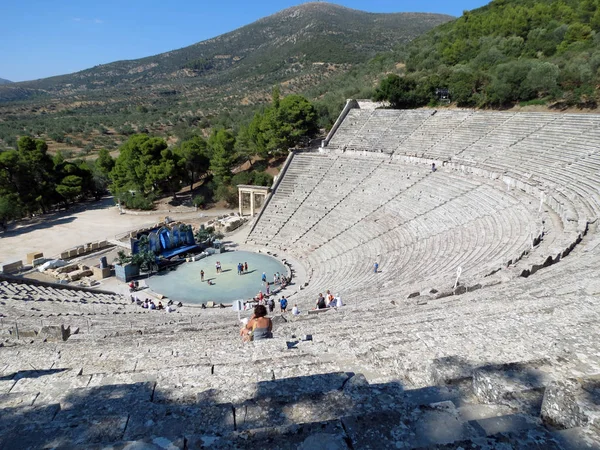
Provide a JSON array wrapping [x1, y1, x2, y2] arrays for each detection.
[[0, 0, 488, 81]]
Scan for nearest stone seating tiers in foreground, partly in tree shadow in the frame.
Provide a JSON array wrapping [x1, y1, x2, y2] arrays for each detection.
[[0, 251, 600, 450]]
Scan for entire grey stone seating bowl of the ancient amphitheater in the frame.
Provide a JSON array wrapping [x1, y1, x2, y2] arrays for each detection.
[[0, 101, 600, 449]]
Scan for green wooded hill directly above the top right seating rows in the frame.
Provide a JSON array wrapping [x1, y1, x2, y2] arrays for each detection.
[[376, 0, 600, 108]]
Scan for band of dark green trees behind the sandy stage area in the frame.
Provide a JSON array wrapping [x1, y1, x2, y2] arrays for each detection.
[[0, 88, 318, 228]]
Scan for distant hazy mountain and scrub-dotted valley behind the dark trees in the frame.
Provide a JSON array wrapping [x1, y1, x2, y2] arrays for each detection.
[[0, 2, 452, 151]]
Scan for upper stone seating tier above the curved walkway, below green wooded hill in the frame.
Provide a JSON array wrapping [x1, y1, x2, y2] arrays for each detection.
[[324, 106, 600, 282]]
